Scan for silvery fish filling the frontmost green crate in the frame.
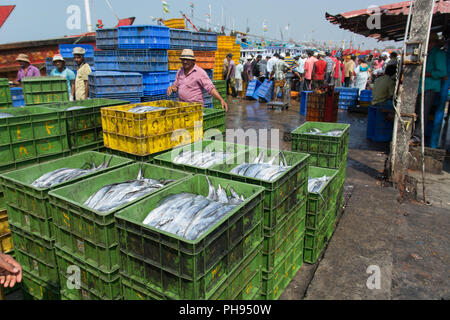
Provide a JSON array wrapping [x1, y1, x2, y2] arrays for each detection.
[[142, 178, 245, 241]]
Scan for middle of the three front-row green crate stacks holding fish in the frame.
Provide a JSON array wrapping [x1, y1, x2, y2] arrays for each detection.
[[49, 163, 191, 300]]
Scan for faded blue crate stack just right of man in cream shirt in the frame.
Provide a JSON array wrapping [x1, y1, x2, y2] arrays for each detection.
[[89, 71, 144, 102]]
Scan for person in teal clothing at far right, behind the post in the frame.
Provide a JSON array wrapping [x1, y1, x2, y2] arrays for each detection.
[[411, 32, 447, 145]]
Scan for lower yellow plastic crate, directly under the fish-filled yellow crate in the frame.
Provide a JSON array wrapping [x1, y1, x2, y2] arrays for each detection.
[[103, 125, 203, 156]]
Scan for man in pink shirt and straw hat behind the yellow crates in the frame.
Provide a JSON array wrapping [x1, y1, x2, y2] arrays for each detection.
[[167, 49, 228, 111]]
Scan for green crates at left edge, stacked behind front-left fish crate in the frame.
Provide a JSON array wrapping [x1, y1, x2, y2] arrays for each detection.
[[0, 107, 69, 172]]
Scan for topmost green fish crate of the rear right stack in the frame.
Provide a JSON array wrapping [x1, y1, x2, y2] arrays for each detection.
[[291, 122, 350, 169]]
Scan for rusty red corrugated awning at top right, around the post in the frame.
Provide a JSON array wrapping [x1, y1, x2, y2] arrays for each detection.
[[325, 0, 450, 41]]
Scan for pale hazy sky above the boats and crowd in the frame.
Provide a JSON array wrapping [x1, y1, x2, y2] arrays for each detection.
[[0, 0, 400, 48]]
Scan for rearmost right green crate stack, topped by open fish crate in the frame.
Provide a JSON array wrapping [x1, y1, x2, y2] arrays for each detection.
[[291, 122, 350, 263]]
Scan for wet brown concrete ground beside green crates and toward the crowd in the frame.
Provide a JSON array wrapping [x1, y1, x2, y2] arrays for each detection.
[[227, 95, 450, 300]]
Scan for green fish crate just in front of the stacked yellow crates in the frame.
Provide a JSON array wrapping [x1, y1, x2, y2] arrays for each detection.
[[153, 140, 251, 174]]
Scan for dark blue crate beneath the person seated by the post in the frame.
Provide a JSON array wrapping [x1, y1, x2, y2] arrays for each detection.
[[366, 104, 394, 142]]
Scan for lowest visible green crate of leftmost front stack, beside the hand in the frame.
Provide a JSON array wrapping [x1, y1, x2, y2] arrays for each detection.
[[22, 270, 61, 300]]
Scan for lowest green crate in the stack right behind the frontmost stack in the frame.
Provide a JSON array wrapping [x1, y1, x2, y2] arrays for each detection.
[[259, 235, 304, 300]]
